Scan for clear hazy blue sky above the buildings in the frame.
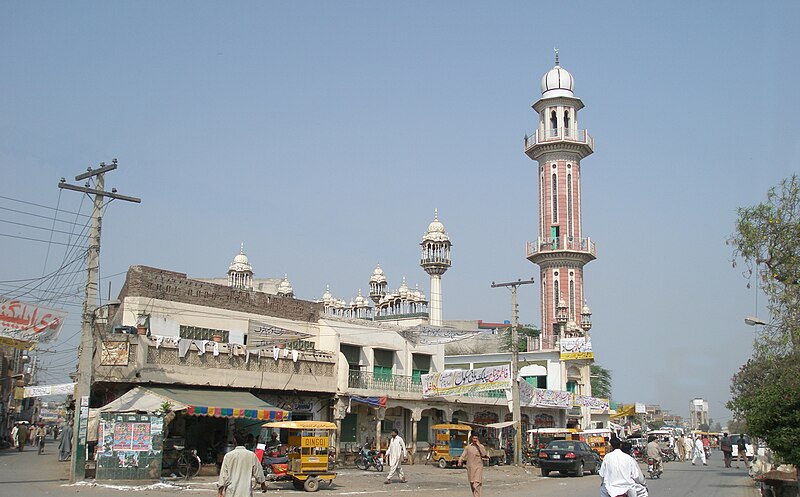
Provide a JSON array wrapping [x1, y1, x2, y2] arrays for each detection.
[[0, 0, 800, 424]]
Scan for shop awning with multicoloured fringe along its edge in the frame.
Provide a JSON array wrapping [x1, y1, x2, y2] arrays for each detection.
[[144, 387, 291, 421]]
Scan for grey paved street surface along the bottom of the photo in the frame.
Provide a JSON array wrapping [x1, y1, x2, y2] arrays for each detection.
[[0, 444, 758, 497]]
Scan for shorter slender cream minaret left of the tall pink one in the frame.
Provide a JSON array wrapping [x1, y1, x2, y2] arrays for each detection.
[[419, 210, 451, 326]]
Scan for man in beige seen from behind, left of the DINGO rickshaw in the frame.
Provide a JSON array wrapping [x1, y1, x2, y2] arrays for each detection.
[[217, 431, 267, 497]]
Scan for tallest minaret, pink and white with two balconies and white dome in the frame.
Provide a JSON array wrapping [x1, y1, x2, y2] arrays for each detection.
[[525, 50, 597, 349]]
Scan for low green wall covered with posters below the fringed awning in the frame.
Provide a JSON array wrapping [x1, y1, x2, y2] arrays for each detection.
[[96, 412, 164, 480]]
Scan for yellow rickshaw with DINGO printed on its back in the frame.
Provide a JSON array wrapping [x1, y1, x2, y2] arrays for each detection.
[[264, 421, 336, 492]]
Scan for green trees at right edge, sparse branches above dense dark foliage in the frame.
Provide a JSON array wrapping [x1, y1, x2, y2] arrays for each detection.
[[727, 175, 800, 476]]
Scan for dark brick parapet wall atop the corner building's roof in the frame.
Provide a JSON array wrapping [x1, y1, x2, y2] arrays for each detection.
[[119, 266, 323, 322]]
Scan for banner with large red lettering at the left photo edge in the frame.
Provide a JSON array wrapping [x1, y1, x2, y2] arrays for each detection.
[[0, 300, 67, 342]]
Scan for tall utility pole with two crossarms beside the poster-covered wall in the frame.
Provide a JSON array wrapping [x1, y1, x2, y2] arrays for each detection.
[[58, 159, 141, 483]]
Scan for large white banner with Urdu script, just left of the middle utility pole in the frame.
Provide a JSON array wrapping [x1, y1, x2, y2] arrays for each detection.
[[422, 365, 511, 398]]
